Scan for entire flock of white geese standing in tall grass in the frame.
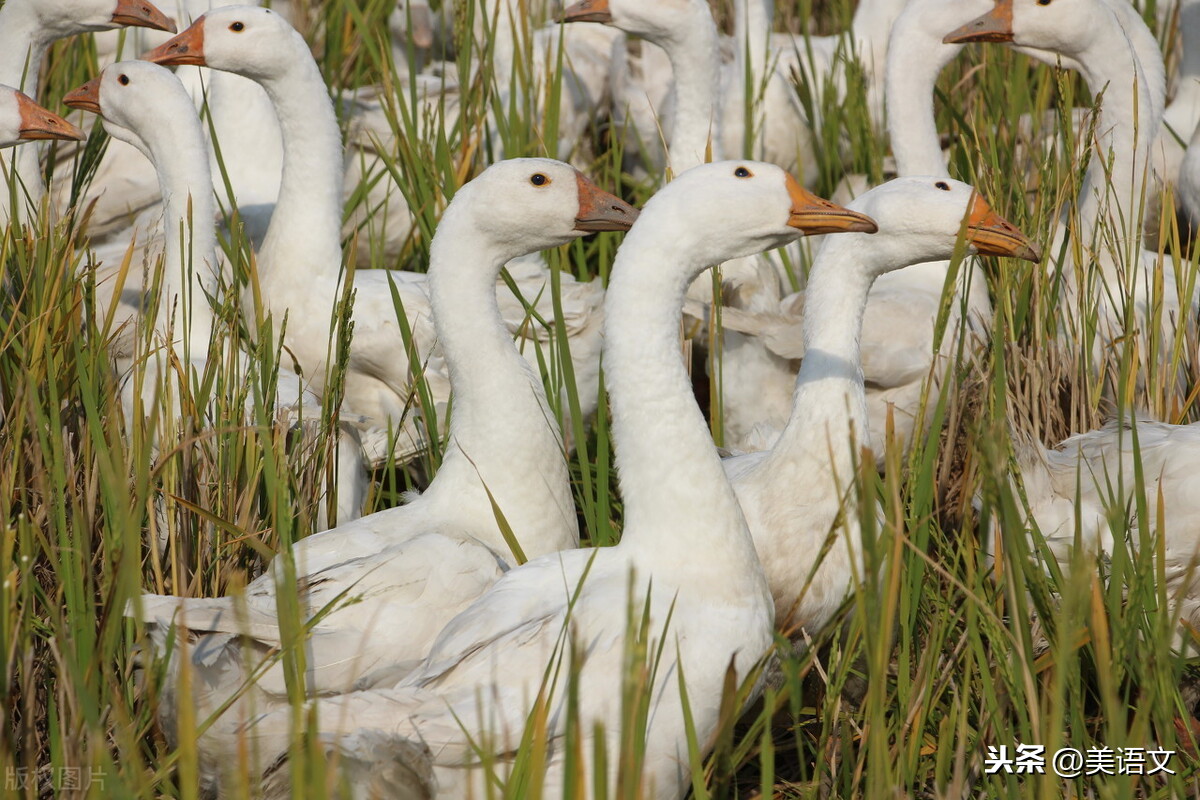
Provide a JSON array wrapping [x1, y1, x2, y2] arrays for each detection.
[[7, 0, 1200, 798]]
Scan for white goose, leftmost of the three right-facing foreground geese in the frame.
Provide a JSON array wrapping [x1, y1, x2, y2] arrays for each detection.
[[129, 160, 637, 782]]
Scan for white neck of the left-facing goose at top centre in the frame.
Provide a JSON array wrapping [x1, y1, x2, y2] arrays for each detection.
[[655, 12, 721, 175]]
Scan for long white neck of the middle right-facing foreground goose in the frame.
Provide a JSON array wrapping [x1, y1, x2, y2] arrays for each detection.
[[604, 215, 757, 576]]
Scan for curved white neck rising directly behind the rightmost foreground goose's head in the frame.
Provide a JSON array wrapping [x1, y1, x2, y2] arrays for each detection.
[[886, 0, 970, 178]]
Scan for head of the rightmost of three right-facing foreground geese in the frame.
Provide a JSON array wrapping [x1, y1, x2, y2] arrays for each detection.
[[826, 176, 1040, 276]]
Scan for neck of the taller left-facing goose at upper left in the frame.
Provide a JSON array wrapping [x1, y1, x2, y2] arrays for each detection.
[[258, 40, 344, 284]]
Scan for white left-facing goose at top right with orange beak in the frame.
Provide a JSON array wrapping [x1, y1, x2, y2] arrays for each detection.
[[946, 0, 1196, 381]]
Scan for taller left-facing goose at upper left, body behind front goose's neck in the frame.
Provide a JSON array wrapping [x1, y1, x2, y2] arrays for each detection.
[[144, 6, 604, 470]]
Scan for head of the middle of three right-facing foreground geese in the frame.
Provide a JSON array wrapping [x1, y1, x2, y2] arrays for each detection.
[[630, 161, 875, 266]]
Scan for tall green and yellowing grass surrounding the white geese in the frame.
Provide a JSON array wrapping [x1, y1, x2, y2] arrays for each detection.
[[7, 0, 1200, 799]]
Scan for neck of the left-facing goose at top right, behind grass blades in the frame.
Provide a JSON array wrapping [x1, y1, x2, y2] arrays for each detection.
[[1074, 4, 1166, 241]]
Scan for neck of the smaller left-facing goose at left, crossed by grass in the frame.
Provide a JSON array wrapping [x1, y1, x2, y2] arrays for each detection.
[[139, 99, 220, 357]]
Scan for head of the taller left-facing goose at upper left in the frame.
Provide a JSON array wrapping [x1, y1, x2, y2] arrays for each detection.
[[142, 6, 302, 80]]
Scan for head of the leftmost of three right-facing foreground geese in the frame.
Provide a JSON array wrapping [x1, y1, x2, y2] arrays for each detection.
[[439, 158, 637, 260]]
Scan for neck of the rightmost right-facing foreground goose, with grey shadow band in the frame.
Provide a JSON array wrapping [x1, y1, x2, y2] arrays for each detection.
[[760, 234, 878, 482]]
